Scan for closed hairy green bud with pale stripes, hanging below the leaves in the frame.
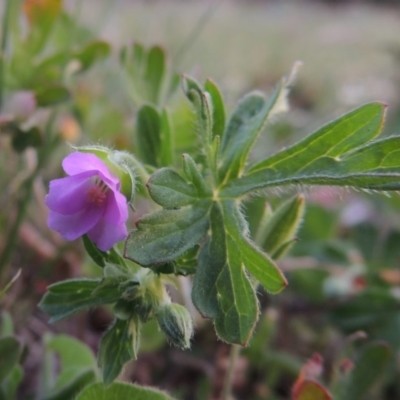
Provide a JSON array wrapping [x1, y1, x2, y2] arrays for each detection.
[[156, 303, 193, 349]]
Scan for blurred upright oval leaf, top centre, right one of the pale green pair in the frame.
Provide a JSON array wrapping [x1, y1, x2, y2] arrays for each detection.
[[144, 46, 165, 104]]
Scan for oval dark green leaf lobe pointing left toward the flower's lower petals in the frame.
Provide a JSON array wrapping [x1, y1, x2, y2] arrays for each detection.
[[125, 205, 210, 267]]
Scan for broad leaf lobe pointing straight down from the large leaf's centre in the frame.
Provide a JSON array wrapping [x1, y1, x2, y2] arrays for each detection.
[[192, 203, 258, 344]]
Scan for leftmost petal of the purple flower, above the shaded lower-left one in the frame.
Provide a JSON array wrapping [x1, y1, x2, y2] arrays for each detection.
[[45, 171, 96, 215]]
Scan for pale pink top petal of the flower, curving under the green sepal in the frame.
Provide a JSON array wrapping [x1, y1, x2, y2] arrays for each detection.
[[62, 151, 120, 188]]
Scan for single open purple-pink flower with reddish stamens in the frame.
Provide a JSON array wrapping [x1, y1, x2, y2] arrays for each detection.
[[45, 152, 128, 251]]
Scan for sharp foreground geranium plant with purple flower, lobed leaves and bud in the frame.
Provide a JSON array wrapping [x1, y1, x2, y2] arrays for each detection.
[[40, 57, 400, 398]]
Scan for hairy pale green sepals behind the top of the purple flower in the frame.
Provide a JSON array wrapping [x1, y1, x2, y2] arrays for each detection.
[[74, 145, 136, 203]]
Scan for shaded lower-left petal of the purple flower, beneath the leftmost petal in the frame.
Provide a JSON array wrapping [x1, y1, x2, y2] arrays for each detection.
[[47, 206, 104, 240]]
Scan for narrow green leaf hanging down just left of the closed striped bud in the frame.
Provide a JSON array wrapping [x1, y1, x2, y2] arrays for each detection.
[[98, 319, 137, 385]]
